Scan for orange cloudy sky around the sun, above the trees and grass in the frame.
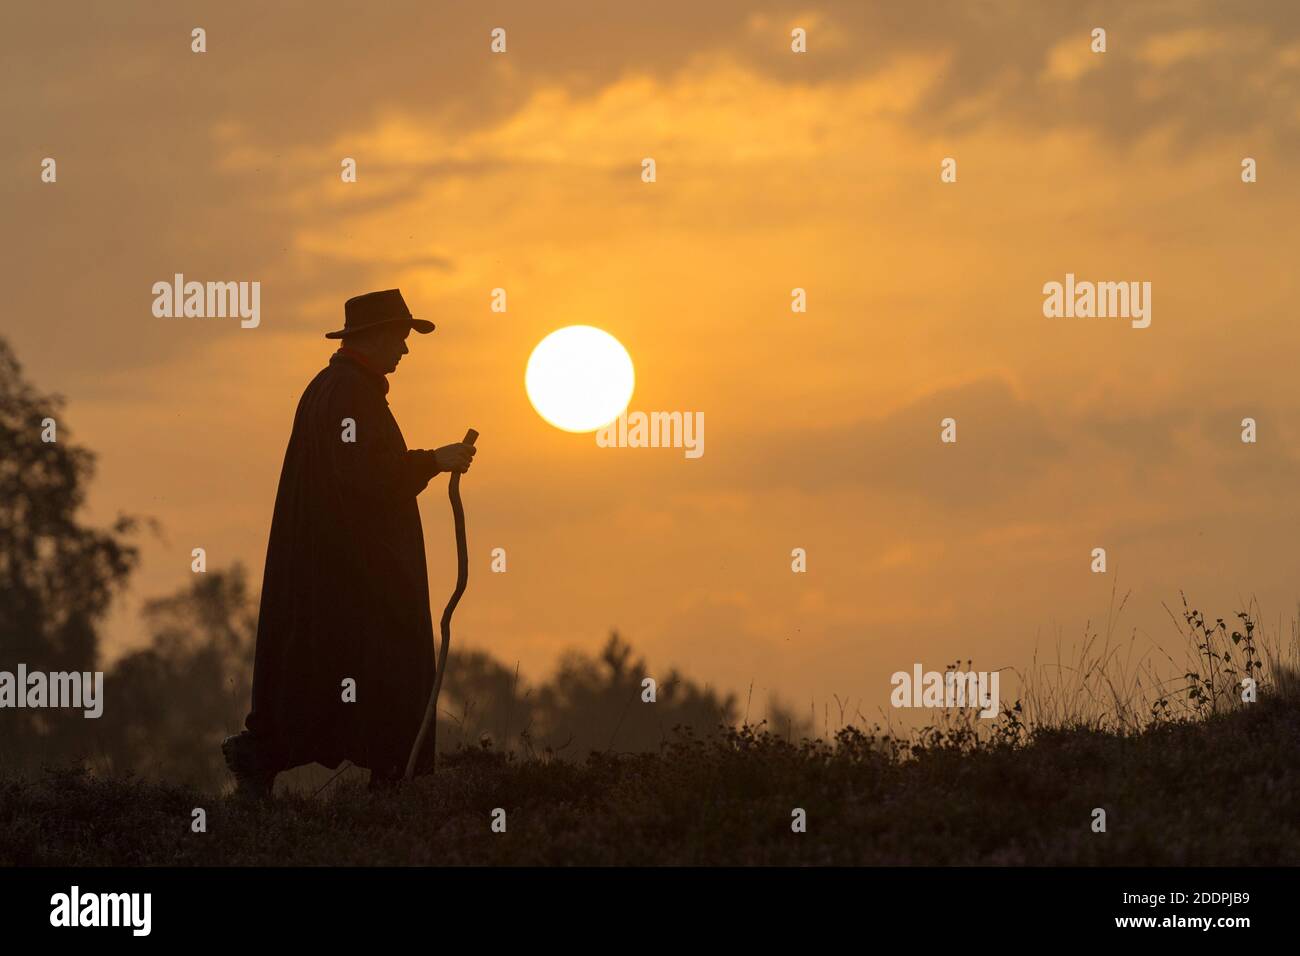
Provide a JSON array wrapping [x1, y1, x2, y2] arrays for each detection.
[[0, 0, 1300, 711]]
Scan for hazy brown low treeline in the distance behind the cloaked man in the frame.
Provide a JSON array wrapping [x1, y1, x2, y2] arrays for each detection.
[[15, 566, 802, 788]]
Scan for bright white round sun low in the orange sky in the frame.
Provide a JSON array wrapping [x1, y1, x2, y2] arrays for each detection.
[[524, 325, 636, 432]]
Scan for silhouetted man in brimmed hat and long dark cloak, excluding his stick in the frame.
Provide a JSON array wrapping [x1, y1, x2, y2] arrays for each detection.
[[221, 289, 475, 795]]
